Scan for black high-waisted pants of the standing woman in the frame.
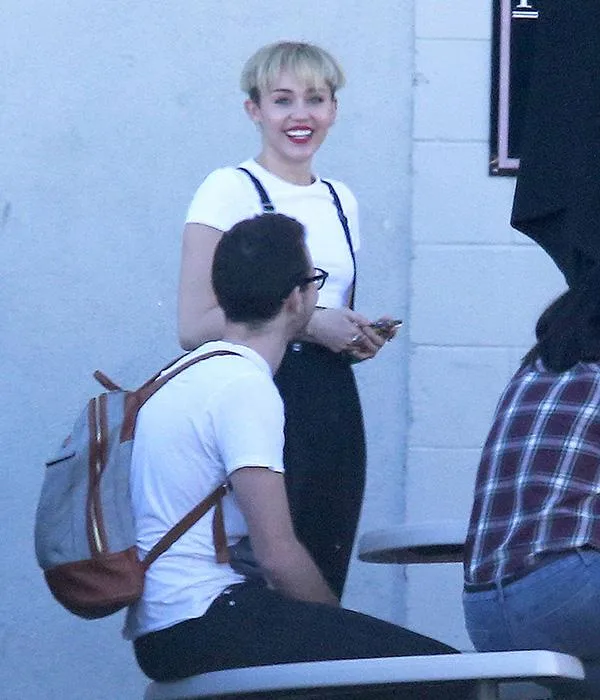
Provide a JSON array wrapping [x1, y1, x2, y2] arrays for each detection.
[[275, 343, 365, 597]]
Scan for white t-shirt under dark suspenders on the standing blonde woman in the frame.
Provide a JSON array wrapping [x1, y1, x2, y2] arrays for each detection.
[[186, 160, 360, 308]]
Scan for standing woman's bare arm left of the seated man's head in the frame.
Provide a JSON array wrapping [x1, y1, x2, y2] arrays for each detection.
[[177, 224, 225, 350]]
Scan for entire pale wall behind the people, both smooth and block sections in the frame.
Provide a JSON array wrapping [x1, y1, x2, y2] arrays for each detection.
[[0, 0, 576, 700]]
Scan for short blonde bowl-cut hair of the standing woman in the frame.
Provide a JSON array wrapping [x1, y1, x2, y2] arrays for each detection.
[[240, 41, 346, 104]]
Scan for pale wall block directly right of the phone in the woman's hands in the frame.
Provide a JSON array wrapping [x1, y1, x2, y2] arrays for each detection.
[[410, 245, 564, 347]]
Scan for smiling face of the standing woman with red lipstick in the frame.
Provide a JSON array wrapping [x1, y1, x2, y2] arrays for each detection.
[[245, 71, 337, 175]]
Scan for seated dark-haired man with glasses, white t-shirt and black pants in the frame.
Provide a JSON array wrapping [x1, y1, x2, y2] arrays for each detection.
[[125, 214, 465, 700]]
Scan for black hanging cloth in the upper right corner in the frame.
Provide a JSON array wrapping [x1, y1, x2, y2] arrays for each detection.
[[511, 0, 600, 286]]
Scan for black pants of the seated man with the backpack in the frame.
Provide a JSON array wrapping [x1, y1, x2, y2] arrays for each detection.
[[135, 582, 468, 700]]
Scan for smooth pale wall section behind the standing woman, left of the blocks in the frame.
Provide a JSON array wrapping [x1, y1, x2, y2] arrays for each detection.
[[0, 0, 414, 700]]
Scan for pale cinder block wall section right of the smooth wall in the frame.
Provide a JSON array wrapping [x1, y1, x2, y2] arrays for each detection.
[[405, 0, 564, 648]]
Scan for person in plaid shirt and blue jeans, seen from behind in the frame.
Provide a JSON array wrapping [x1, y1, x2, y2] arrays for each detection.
[[464, 268, 600, 697]]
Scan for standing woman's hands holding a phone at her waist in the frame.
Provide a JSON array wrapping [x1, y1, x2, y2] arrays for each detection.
[[303, 308, 377, 353]]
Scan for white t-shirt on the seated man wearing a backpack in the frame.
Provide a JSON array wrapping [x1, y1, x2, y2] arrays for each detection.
[[123, 341, 284, 639]]
